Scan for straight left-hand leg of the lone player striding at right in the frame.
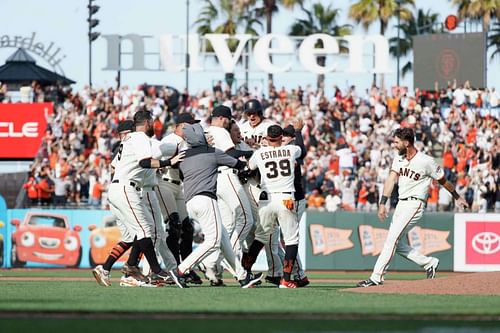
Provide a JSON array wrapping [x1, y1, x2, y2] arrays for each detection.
[[370, 201, 423, 283]]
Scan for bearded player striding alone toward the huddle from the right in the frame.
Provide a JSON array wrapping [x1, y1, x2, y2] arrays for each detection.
[[358, 128, 468, 287]]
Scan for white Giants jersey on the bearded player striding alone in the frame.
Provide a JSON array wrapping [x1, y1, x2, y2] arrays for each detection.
[[391, 152, 444, 201]]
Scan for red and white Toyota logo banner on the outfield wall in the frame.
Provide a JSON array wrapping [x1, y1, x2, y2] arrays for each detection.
[[454, 214, 500, 272]]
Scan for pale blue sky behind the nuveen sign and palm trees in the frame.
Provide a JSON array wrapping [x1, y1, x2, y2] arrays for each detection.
[[0, 0, 500, 92]]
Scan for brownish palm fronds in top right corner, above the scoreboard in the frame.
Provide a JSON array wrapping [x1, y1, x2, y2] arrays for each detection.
[[451, 0, 500, 32]]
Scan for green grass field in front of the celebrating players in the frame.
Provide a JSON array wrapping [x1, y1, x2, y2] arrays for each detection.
[[0, 270, 500, 333]]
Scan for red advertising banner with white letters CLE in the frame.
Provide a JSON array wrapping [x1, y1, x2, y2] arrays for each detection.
[[0, 103, 53, 159]]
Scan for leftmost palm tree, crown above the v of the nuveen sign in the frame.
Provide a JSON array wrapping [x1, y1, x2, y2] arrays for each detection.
[[194, 0, 262, 85]]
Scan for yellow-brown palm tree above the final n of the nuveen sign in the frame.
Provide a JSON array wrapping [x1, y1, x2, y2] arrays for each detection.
[[349, 0, 415, 85]]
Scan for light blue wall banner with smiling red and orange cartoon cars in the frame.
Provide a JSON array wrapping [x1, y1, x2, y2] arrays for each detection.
[[7, 209, 115, 267]]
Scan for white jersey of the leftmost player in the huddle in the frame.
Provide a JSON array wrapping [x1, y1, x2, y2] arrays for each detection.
[[113, 132, 153, 187]]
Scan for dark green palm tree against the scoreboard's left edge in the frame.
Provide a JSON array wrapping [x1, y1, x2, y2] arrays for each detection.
[[389, 9, 439, 77]]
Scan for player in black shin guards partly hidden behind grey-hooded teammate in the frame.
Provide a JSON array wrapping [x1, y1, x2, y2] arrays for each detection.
[[156, 113, 202, 284]]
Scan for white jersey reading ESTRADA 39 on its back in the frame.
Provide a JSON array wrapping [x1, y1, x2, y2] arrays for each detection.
[[248, 145, 301, 193]]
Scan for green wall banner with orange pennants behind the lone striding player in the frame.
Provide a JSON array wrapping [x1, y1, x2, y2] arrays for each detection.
[[305, 211, 453, 270]]
